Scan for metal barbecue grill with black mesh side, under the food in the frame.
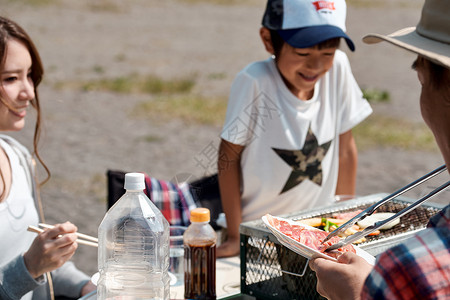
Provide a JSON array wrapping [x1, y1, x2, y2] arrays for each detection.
[[240, 194, 444, 300]]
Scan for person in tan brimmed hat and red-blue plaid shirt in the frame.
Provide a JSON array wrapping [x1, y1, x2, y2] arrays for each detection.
[[309, 0, 450, 300]]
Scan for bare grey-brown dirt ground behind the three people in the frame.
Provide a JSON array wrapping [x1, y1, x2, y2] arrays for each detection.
[[0, 0, 448, 274]]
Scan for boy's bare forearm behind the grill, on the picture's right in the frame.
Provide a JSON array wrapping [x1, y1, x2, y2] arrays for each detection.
[[336, 130, 358, 195]]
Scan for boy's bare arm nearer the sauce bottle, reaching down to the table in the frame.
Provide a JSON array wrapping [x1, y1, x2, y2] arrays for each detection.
[[217, 140, 244, 257]]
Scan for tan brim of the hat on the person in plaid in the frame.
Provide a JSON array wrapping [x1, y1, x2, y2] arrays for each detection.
[[363, 27, 450, 68]]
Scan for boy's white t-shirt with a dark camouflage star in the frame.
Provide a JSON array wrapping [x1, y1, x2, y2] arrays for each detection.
[[219, 50, 372, 221]]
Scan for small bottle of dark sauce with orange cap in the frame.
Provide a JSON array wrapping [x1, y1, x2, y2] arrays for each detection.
[[183, 208, 217, 300]]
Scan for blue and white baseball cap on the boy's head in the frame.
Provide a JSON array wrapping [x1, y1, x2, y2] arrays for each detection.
[[262, 0, 355, 51]]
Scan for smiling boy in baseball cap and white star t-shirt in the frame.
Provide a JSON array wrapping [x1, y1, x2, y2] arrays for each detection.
[[217, 0, 372, 257]]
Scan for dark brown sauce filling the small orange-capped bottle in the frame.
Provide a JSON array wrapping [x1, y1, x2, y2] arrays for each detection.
[[184, 241, 216, 300]]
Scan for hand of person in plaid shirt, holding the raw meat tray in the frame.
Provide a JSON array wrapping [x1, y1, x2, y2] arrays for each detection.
[[309, 252, 372, 300]]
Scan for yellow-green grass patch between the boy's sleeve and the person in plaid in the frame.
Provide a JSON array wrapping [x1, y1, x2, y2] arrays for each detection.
[[353, 115, 438, 151]]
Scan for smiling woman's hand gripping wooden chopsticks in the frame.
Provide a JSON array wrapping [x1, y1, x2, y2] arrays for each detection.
[[23, 222, 78, 278]]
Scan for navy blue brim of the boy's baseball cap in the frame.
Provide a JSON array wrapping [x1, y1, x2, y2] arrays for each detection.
[[278, 25, 355, 51]]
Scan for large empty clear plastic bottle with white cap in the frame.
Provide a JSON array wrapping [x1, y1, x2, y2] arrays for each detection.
[[97, 173, 170, 300]]
